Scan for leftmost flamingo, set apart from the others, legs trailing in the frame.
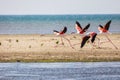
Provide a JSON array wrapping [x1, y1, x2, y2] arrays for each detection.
[[53, 27, 74, 49]]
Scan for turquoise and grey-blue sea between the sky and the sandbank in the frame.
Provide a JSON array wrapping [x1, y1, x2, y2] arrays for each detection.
[[0, 14, 120, 34]]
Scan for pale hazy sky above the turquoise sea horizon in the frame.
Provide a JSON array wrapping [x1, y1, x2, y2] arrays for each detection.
[[0, 0, 120, 15]]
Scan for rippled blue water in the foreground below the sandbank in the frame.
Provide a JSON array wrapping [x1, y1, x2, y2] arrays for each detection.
[[0, 62, 120, 80]]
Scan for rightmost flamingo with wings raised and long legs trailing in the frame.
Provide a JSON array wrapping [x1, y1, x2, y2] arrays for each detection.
[[98, 20, 118, 49]]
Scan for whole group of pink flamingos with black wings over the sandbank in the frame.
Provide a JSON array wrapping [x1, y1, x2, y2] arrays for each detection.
[[53, 20, 118, 49]]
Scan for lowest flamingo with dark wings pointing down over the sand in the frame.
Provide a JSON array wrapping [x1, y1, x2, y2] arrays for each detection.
[[80, 32, 97, 48]]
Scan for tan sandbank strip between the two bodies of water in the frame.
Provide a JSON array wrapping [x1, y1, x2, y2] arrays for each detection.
[[0, 34, 120, 62]]
